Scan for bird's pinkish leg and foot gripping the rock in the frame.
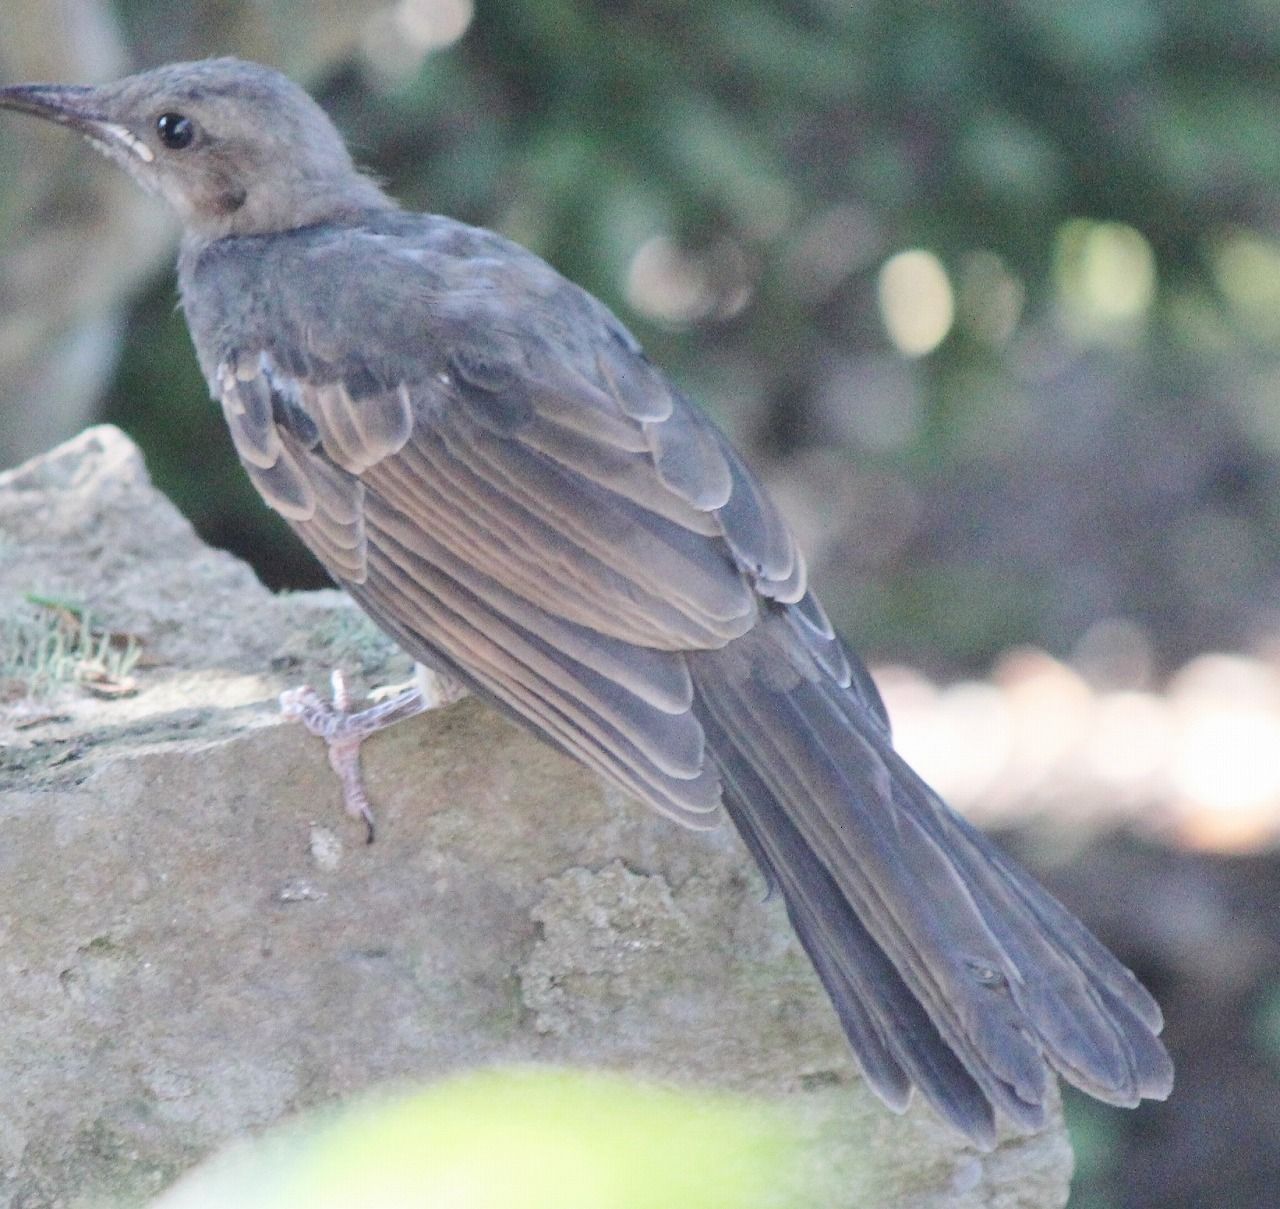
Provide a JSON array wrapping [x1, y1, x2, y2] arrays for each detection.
[[280, 664, 467, 843]]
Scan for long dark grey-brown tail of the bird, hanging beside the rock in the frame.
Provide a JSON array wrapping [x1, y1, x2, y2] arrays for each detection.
[[691, 612, 1172, 1146]]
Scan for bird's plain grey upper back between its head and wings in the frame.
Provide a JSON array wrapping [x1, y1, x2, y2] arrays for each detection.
[[179, 210, 609, 376]]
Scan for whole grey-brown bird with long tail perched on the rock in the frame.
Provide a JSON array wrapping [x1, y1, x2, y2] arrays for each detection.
[[0, 59, 1172, 1148]]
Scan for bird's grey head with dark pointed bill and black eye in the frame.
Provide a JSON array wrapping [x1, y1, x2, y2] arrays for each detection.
[[0, 59, 392, 239]]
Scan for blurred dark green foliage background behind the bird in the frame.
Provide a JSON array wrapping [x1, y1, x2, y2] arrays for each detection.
[[102, 0, 1280, 669]]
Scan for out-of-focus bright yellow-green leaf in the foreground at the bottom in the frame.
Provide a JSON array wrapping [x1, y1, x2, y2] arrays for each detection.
[[155, 1070, 815, 1209]]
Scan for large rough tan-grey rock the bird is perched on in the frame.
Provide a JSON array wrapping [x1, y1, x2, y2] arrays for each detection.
[[0, 427, 1071, 1209]]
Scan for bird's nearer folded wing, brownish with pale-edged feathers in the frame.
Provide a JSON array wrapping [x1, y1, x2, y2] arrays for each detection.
[[220, 342, 755, 826]]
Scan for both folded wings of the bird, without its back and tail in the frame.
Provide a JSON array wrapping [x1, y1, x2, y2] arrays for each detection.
[[216, 275, 865, 825]]
